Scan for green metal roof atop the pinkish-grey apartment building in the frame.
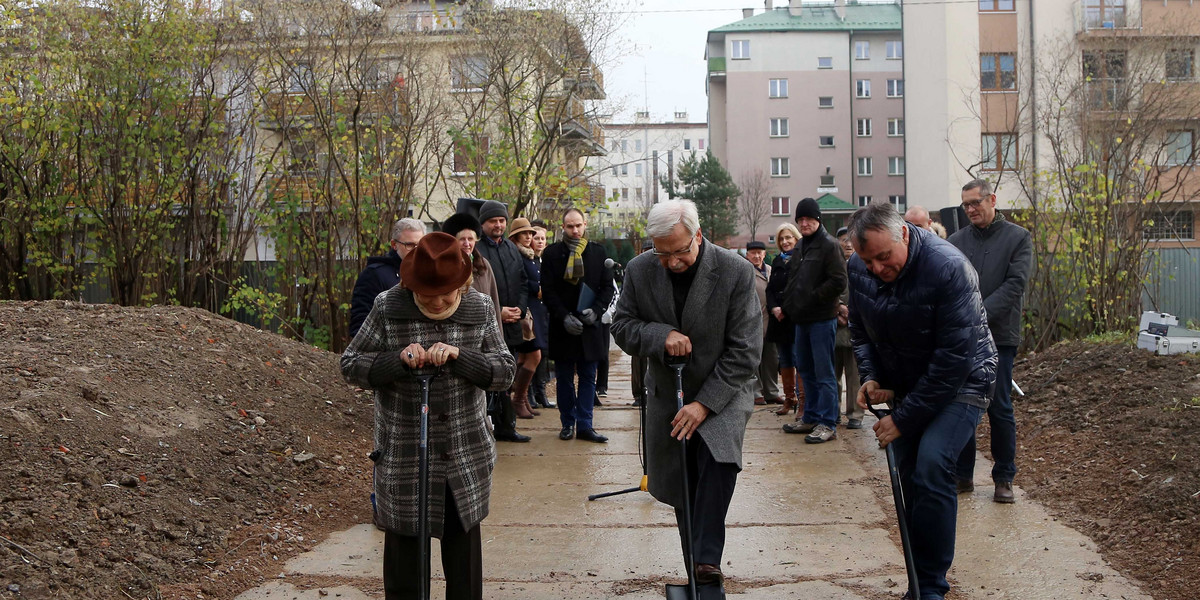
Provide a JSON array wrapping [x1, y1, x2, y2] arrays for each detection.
[[709, 2, 900, 37]]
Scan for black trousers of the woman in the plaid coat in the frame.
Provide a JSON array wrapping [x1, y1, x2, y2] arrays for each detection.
[[383, 488, 484, 600]]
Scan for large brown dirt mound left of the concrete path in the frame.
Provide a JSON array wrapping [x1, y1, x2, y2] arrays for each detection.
[[0, 302, 372, 599]]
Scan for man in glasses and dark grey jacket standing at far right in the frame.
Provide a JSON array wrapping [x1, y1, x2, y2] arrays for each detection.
[[948, 179, 1033, 504]]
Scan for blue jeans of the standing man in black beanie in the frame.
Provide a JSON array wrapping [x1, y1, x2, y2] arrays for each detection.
[[796, 319, 838, 428]]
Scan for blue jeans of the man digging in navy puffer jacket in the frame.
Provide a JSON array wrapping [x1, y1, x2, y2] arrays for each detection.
[[892, 402, 983, 598]]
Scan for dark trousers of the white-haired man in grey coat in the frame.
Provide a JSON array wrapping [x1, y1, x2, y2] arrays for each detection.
[[676, 436, 738, 566]]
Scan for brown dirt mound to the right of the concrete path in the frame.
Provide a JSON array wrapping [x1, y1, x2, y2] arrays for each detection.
[[1012, 342, 1200, 600]]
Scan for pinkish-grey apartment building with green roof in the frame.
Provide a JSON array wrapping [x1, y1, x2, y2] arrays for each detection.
[[706, 0, 907, 245]]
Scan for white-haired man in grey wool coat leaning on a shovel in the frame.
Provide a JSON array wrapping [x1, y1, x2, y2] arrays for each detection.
[[612, 200, 762, 583]]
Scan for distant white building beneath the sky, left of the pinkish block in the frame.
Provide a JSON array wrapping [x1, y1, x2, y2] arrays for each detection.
[[593, 112, 708, 238]]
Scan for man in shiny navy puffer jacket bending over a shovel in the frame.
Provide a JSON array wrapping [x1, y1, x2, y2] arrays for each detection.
[[847, 203, 996, 600]]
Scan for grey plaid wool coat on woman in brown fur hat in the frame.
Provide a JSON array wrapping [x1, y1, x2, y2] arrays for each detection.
[[342, 286, 516, 538]]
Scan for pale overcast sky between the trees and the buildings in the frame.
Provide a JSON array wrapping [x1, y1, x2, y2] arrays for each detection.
[[605, 0, 748, 122]]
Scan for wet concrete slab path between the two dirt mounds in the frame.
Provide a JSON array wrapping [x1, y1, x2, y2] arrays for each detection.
[[236, 353, 1150, 600]]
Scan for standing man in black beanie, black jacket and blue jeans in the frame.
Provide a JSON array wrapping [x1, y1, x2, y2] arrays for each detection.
[[784, 198, 846, 444]]
